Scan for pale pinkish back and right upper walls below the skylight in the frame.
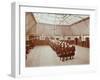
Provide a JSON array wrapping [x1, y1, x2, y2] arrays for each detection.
[[33, 20, 89, 36]]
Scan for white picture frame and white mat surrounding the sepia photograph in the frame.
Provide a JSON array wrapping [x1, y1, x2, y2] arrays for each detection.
[[11, 2, 96, 77]]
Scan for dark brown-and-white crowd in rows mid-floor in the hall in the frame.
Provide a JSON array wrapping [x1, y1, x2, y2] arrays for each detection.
[[49, 40, 75, 61]]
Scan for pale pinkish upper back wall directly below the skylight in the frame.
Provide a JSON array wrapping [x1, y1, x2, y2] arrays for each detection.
[[36, 23, 72, 36]]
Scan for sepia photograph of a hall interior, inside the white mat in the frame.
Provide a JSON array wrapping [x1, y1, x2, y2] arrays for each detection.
[[25, 12, 90, 67]]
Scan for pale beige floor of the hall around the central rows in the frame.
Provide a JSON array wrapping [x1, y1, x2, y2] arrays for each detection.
[[26, 46, 89, 67]]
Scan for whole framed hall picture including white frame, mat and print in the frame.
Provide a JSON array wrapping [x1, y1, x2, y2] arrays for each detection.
[[11, 3, 96, 77]]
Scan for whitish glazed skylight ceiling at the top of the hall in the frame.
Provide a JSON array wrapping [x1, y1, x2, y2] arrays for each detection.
[[33, 13, 89, 25]]
